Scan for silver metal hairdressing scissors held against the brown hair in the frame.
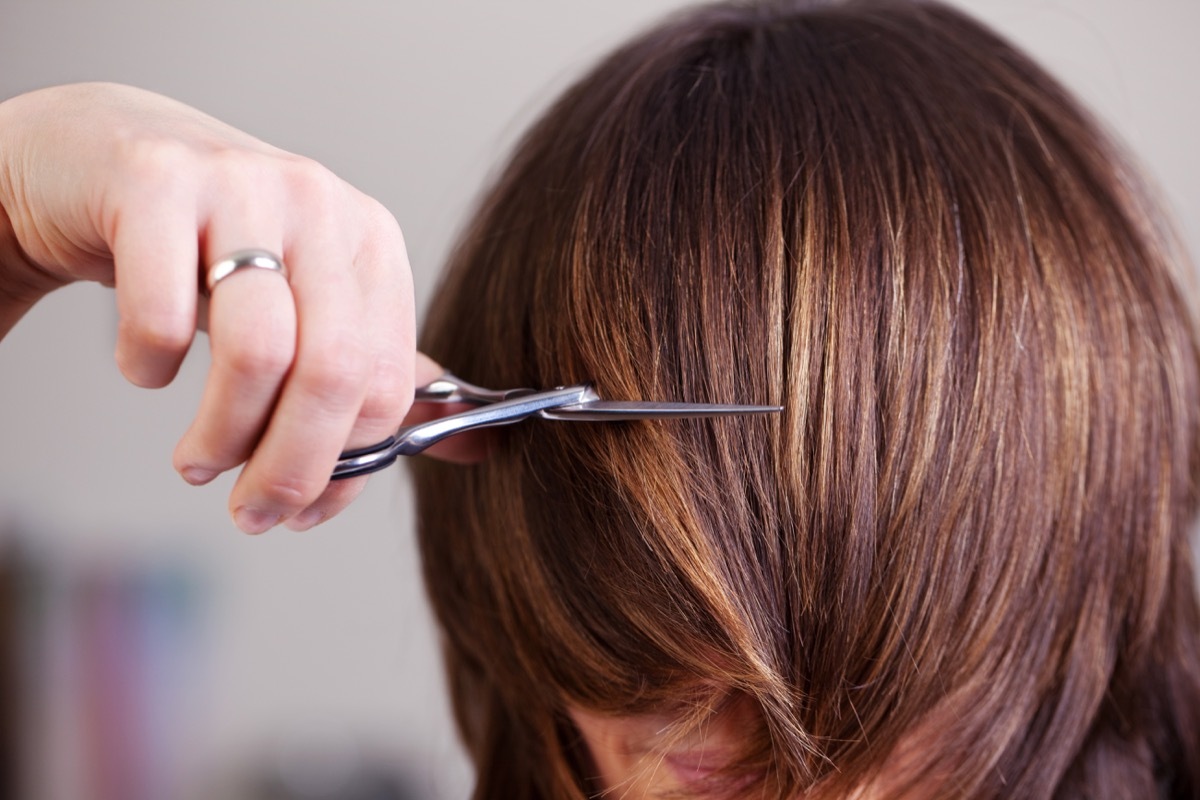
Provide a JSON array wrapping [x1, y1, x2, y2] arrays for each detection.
[[332, 373, 782, 481]]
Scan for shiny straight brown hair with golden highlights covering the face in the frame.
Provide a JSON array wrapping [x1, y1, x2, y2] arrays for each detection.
[[416, 0, 1200, 798]]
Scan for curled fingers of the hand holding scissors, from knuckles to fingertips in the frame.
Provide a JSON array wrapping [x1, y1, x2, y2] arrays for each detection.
[[110, 136, 415, 533]]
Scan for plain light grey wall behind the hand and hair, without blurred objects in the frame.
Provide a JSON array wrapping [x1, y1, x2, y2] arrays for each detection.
[[0, 0, 1200, 796]]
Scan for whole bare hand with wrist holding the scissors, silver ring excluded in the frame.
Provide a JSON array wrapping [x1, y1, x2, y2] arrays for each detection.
[[0, 84, 439, 533]]
